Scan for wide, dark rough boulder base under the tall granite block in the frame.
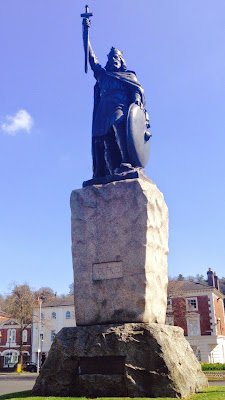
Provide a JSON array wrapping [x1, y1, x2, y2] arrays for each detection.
[[33, 323, 208, 398]]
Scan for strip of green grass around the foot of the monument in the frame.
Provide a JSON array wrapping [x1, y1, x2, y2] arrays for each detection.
[[0, 386, 225, 400]]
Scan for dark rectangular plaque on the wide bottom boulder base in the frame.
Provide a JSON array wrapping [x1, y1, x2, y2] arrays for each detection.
[[79, 356, 126, 375]]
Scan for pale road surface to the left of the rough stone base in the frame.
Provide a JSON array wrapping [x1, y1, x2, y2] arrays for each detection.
[[0, 372, 37, 395]]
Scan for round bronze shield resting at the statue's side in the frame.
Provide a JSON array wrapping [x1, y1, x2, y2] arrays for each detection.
[[127, 103, 151, 168]]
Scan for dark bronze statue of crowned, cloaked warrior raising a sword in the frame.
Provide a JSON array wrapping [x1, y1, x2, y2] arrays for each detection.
[[81, 6, 150, 179]]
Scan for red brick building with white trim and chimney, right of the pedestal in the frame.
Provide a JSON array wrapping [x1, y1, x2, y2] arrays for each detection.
[[166, 268, 225, 363]]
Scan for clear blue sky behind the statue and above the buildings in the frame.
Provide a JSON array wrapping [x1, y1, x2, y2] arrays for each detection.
[[0, 0, 225, 294]]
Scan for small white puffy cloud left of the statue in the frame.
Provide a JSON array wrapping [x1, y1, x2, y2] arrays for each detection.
[[1, 110, 34, 135]]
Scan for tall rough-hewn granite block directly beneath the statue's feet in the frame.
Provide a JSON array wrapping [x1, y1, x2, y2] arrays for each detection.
[[71, 177, 168, 325]]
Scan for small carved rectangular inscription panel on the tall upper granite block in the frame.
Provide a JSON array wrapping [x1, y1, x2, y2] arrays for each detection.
[[92, 261, 123, 281]]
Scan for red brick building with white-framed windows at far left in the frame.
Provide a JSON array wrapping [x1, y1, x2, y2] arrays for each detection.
[[0, 311, 31, 371]]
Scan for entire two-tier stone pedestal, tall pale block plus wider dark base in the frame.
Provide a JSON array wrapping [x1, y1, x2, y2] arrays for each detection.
[[33, 178, 208, 398]]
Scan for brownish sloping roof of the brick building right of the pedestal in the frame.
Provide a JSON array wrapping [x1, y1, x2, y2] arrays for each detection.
[[168, 280, 224, 298]]
